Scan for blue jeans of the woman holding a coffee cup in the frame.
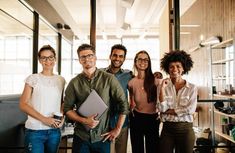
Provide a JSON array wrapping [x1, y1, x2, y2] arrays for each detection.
[[25, 129, 61, 153]]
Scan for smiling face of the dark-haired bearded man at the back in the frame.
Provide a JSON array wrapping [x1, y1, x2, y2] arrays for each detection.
[[109, 49, 125, 68]]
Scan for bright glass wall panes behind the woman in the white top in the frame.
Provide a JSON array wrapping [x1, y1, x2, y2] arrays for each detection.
[[0, 0, 72, 96]]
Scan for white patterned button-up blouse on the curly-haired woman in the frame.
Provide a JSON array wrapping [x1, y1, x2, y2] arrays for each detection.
[[158, 82, 197, 122]]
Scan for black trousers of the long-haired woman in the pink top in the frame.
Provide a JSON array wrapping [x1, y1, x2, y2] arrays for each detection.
[[130, 111, 160, 153]]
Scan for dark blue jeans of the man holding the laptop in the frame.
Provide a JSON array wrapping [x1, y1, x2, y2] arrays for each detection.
[[72, 135, 110, 153]]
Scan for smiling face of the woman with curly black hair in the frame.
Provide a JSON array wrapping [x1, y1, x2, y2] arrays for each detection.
[[169, 62, 184, 78]]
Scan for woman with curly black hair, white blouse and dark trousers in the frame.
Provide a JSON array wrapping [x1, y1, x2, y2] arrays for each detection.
[[158, 51, 197, 153]]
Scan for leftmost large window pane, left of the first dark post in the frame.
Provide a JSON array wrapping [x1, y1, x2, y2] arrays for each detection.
[[0, 0, 33, 95]]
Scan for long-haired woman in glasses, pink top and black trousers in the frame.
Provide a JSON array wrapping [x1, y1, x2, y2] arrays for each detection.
[[128, 50, 160, 153]]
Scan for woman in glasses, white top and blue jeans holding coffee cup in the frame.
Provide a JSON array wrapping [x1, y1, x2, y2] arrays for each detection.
[[19, 45, 65, 153]]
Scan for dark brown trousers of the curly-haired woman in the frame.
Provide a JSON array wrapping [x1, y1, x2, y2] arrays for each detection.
[[160, 122, 195, 153]]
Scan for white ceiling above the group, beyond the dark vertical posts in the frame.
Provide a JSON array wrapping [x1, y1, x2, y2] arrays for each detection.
[[48, 0, 196, 39]]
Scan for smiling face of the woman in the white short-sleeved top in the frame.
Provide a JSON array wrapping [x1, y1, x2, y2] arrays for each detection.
[[39, 50, 56, 70]]
